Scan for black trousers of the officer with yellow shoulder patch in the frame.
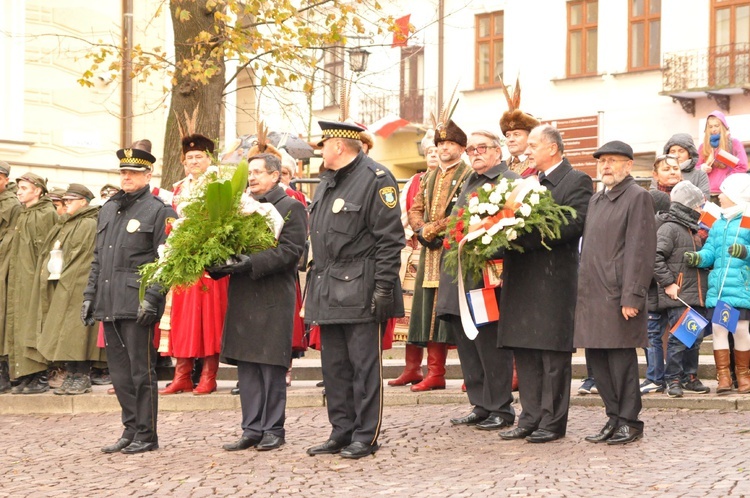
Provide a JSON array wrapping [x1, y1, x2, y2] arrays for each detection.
[[320, 323, 383, 445]]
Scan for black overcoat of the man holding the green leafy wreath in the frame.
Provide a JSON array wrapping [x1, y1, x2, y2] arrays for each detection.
[[221, 185, 307, 368]]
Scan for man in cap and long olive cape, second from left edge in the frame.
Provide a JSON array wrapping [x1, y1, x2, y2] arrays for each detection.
[[5, 173, 58, 394]]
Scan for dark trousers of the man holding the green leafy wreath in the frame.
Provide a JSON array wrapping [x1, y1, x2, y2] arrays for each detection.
[[237, 361, 287, 438]]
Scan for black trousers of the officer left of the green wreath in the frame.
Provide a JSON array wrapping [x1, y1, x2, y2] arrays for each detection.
[[103, 320, 159, 442]]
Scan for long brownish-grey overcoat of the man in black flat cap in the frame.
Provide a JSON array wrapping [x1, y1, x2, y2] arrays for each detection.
[[575, 175, 656, 349]]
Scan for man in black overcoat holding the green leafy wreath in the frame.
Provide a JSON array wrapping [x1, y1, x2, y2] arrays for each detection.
[[208, 154, 307, 451]]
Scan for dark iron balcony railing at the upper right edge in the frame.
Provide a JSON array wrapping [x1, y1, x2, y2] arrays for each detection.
[[662, 43, 750, 95]]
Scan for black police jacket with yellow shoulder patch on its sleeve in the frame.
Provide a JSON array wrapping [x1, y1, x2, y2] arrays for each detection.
[[305, 152, 406, 324]]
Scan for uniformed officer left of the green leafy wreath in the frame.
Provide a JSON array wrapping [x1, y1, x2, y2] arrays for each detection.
[[81, 144, 176, 453]]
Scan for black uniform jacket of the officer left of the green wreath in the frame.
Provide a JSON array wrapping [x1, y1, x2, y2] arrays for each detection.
[[83, 185, 177, 322]]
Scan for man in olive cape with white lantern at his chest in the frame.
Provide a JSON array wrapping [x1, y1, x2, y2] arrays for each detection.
[[31, 183, 104, 395]]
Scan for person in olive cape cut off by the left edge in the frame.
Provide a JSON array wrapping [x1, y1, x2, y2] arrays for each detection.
[[0, 161, 21, 394]]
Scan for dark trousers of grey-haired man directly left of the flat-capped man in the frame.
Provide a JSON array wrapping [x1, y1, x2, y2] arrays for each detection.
[[513, 348, 576, 435]]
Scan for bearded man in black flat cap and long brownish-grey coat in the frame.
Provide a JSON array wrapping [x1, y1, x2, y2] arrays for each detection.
[[574, 140, 656, 444]]
